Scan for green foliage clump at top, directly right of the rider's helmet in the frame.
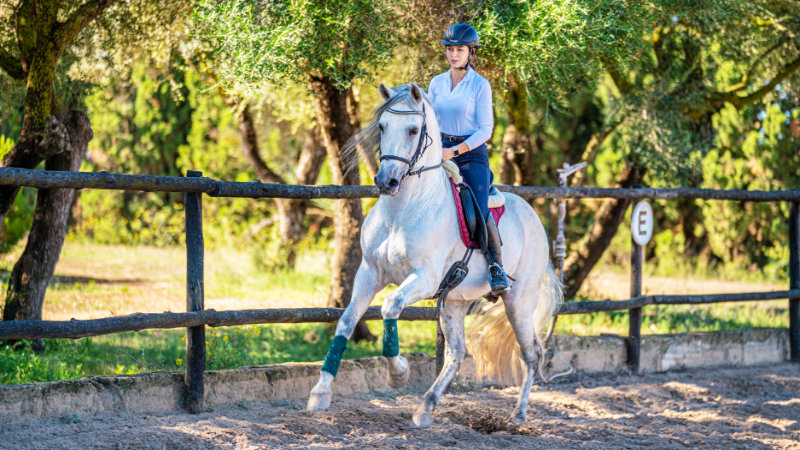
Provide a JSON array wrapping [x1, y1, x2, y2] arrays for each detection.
[[471, 0, 642, 103]]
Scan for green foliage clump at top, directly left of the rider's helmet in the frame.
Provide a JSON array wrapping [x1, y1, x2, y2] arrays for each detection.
[[193, 0, 397, 93]]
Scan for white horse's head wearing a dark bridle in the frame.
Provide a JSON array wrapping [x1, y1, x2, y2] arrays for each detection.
[[375, 83, 441, 196]]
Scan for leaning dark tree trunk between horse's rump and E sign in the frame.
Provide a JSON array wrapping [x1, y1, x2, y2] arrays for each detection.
[[564, 165, 645, 298]]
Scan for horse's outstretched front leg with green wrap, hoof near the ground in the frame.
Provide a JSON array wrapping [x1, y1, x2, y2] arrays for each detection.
[[306, 260, 380, 411]]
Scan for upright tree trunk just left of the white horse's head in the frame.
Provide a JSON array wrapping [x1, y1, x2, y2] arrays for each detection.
[[310, 77, 376, 341]]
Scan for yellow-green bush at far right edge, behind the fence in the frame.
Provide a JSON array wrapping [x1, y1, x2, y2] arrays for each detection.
[[702, 102, 800, 280]]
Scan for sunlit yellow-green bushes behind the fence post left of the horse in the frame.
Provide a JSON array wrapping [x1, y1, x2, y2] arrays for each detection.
[[73, 53, 278, 250]]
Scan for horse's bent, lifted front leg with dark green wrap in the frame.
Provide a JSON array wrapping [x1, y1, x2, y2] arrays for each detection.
[[381, 273, 435, 389]]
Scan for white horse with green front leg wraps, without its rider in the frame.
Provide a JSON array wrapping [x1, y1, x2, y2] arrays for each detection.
[[307, 84, 562, 427]]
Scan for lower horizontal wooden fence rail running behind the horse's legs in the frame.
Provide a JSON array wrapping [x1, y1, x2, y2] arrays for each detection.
[[0, 289, 800, 339]]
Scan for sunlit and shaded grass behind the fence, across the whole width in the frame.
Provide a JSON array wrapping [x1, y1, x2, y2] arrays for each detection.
[[0, 242, 788, 384]]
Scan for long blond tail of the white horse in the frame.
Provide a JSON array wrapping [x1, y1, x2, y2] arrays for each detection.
[[467, 264, 564, 385]]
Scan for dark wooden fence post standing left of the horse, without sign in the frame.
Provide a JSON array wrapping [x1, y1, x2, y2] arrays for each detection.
[[183, 170, 206, 414]]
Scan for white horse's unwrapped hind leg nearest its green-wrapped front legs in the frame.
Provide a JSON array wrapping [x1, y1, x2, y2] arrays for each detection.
[[411, 302, 469, 428]]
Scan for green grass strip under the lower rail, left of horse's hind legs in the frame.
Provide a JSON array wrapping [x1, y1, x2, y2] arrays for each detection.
[[0, 321, 436, 384]]
